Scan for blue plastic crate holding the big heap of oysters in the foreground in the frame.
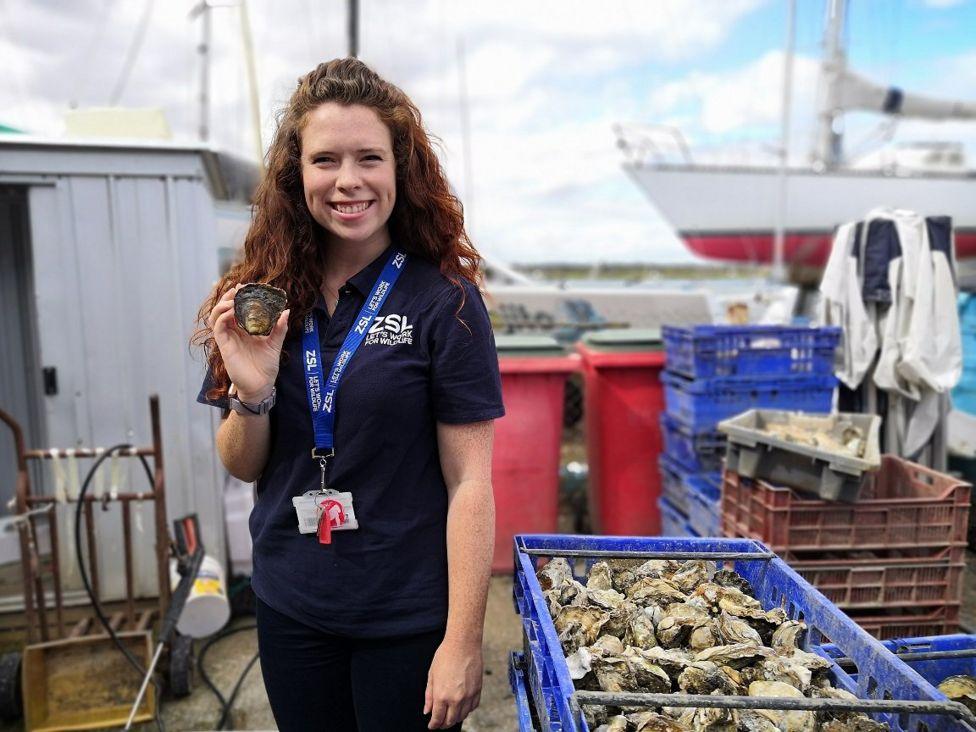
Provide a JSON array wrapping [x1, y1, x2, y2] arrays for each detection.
[[513, 534, 955, 732]]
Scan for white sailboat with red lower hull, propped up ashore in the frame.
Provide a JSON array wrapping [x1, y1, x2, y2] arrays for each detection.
[[616, 0, 976, 267]]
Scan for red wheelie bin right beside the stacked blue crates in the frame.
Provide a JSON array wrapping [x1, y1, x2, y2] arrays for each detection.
[[577, 329, 664, 536]]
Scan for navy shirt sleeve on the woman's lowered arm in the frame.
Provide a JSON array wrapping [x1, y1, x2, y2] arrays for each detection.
[[430, 282, 505, 424]]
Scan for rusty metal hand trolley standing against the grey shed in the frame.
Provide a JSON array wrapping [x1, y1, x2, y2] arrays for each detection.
[[0, 395, 193, 730]]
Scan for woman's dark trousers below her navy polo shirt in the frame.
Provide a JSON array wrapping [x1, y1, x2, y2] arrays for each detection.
[[255, 598, 461, 732]]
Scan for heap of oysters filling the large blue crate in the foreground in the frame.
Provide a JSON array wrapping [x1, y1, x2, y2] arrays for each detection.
[[537, 558, 887, 732]]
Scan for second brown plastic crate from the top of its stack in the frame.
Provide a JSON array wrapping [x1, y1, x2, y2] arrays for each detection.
[[783, 544, 966, 610]]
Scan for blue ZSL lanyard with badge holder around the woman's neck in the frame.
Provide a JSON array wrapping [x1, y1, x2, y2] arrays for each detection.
[[292, 249, 407, 544]]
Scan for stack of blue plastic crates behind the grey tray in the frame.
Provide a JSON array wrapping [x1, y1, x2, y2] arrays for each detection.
[[659, 325, 840, 536]]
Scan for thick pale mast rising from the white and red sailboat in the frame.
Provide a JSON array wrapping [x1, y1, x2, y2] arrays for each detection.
[[814, 0, 847, 169]]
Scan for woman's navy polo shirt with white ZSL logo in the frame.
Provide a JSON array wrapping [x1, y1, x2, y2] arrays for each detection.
[[197, 250, 504, 638]]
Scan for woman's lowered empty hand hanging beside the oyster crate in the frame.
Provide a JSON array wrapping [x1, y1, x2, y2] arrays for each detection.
[[424, 638, 484, 729]]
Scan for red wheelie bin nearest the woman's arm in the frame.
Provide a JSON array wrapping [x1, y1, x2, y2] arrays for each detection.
[[491, 335, 579, 574]]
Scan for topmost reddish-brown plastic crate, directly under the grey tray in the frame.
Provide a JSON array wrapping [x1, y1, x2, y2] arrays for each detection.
[[722, 455, 971, 552]]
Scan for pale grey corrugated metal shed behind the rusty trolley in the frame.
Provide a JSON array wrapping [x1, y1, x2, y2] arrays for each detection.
[[0, 136, 256, 597]]
